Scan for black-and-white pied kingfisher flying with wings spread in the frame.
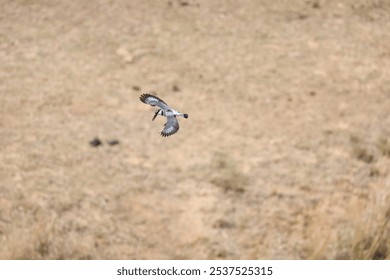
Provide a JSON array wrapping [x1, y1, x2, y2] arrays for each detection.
[[139, 93, 188, 137]]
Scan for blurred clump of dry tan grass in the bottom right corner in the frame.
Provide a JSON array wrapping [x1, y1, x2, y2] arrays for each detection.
[[303, 190, 390, 260]]
